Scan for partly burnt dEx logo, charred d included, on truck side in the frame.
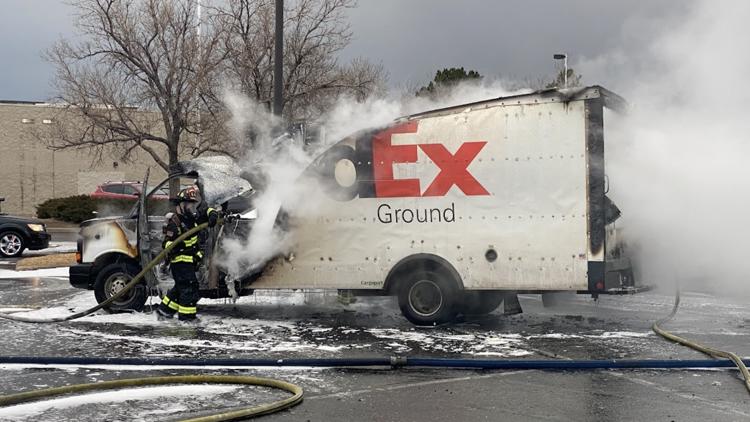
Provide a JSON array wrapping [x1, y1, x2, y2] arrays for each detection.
[[318, 121, 490, 201]]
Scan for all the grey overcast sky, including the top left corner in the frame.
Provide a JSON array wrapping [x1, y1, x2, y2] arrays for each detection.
[[0, 0, 686, 100]]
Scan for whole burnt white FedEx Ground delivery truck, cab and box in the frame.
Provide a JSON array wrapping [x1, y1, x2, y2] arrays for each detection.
[[71, 86, 643, 325]]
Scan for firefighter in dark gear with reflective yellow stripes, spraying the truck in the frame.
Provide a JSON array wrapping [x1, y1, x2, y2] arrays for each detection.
[[156, 186, 219, 321]]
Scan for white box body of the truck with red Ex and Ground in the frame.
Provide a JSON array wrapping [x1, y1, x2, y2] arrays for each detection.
[[252, 87, 619, 291]]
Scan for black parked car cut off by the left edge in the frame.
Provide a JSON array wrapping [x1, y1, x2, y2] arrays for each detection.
[[0, 214, 52, 258]]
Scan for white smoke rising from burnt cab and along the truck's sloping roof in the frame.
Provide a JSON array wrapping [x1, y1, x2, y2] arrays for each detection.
[[214, 80, 524, 279]]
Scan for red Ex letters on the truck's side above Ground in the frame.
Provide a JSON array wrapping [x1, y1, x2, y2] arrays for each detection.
[[372, 121, 490, 198]]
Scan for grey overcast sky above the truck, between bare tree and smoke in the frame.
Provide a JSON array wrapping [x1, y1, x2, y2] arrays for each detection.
[[344, 0, 686, 86]]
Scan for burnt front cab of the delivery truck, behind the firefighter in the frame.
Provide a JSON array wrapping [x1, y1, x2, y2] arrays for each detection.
[[70, 156, 254, 311]]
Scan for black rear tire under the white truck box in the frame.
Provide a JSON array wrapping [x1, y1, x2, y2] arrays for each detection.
[[398, 270, 461, 325]]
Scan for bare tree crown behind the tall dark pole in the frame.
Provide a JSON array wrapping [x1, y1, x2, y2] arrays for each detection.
[[213, 0, 385, 124]]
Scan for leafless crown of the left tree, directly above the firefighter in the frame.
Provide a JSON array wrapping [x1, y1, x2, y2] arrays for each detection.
[[46, 0, 226, 194]]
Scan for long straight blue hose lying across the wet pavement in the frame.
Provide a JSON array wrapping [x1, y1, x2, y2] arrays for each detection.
[[0, 356, 750, 370]]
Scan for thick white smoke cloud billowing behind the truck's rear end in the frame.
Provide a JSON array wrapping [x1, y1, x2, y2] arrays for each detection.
[[576, 1, 750, 292]]
